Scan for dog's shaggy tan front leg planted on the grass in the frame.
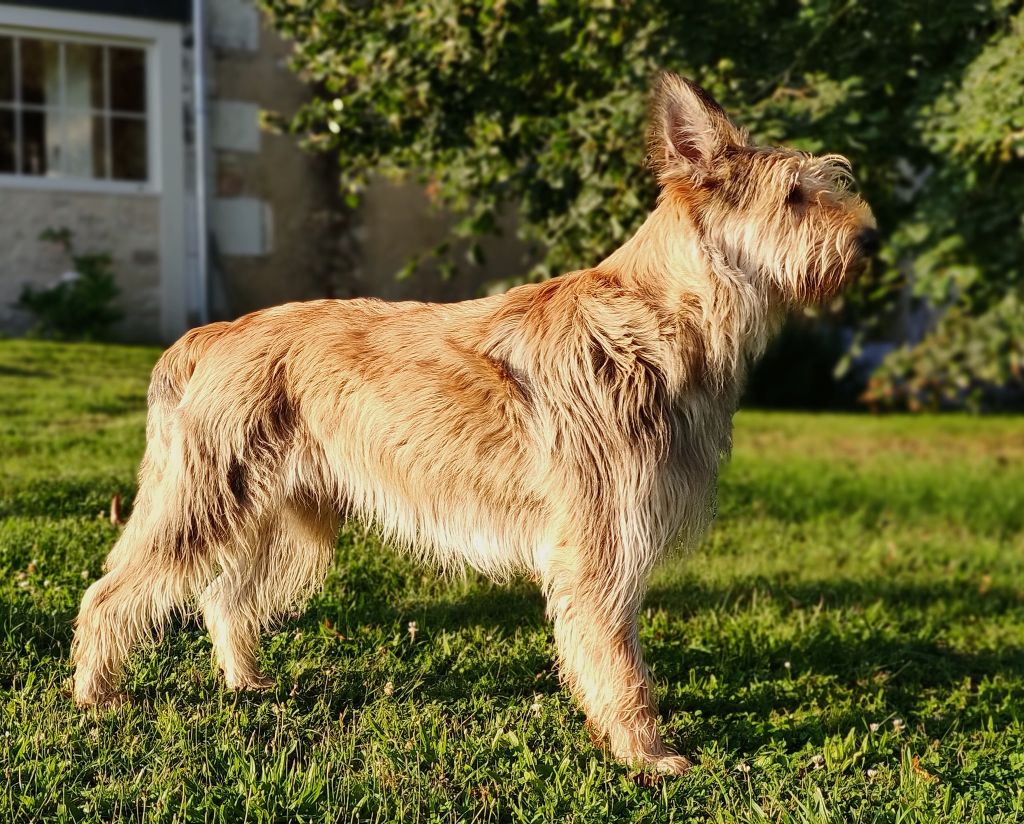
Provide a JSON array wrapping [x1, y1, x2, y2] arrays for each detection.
[[546, 552, 690, 774]]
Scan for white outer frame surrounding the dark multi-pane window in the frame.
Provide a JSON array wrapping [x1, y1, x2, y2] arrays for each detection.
[[0, 5, 173, 194]]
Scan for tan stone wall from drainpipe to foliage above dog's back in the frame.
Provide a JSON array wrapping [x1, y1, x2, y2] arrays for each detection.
[[203, 0, 529, 317]]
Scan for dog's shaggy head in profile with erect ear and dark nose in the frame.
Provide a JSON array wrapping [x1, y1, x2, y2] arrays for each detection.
[[648, 73, 879, 304]]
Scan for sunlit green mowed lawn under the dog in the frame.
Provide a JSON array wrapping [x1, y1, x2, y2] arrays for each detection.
[[0, 341, 1024, 822]]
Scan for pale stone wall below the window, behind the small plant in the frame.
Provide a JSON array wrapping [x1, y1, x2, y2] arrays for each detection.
[[0, 187, 160, 343]]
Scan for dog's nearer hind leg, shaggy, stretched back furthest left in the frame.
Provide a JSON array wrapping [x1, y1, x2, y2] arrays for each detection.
[[72, 395, 276, 705]]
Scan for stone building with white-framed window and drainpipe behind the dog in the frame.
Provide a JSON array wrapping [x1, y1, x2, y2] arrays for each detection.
[[0, 0, 526, 342]]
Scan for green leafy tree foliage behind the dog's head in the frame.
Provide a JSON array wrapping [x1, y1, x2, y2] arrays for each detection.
[[262, 0, 1024, 402]]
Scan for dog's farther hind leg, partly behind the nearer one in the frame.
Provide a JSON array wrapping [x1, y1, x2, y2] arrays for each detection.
[[201, 503, 338, 690]]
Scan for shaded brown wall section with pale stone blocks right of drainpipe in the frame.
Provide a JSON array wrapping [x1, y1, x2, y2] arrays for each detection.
[[208, 0, 348, 317]]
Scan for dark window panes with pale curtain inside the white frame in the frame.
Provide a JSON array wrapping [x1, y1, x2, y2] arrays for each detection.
[[0, 30, 150, 183]]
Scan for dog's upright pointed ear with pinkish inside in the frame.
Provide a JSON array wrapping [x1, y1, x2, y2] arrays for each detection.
[[647, 72, 746, 185]]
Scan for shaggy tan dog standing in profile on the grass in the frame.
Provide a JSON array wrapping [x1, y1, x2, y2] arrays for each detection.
[[73, 75, 877, 773]]
